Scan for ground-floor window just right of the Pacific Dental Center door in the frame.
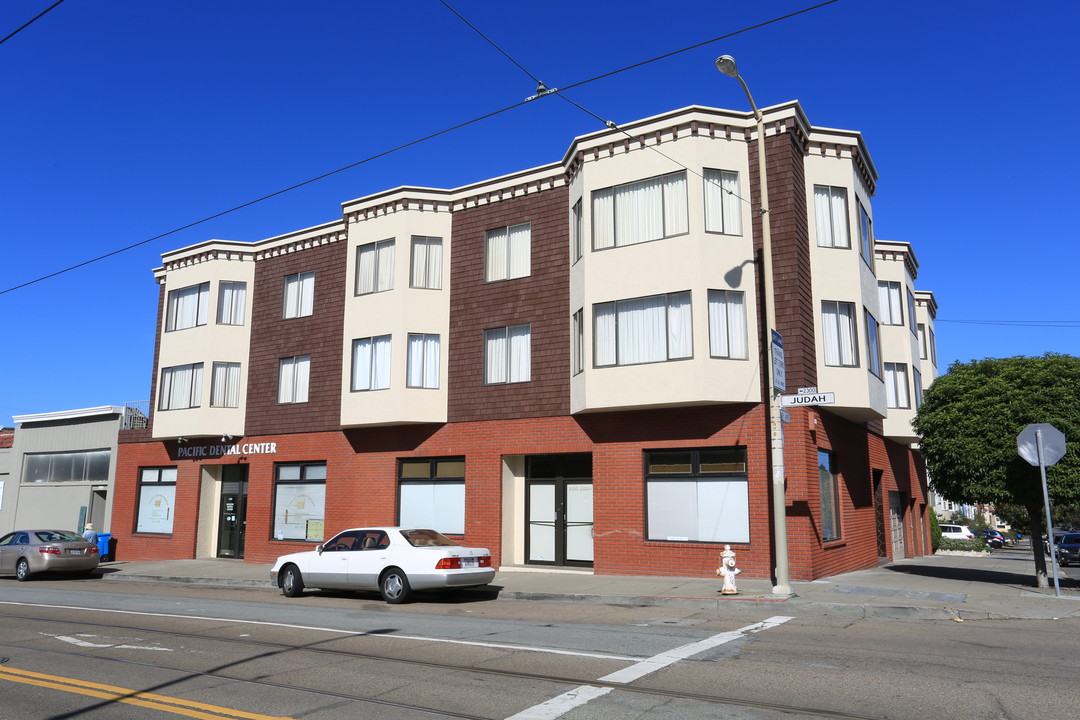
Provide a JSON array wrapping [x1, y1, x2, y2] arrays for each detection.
[[273, 462, 326, 543]]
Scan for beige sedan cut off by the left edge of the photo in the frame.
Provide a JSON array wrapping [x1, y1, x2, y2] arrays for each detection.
[[0, 530, 100, 581]]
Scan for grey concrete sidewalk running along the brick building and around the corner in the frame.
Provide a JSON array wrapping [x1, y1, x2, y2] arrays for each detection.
[[100, 547, 1080, 620]]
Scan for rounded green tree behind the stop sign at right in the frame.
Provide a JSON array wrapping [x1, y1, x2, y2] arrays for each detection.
[[914, 353, 1080, 587]]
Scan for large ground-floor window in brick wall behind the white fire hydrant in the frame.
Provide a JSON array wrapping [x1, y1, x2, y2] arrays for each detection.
[[645, 447, 750, 543]]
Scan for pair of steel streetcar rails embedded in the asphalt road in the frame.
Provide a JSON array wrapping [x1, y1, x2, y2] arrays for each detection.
[[0, 614, 881, 720]]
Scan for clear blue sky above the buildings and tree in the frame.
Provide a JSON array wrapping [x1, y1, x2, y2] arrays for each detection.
[[0, 0, 1080, 425]]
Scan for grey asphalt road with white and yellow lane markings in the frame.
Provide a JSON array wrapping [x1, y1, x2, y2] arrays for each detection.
[[0, 579, 1080, 720]]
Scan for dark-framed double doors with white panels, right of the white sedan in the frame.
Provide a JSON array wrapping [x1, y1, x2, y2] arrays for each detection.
[[525, 453, 593, 567]]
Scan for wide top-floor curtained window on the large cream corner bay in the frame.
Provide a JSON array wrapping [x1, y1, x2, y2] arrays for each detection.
[[593, 171, 690, 250]]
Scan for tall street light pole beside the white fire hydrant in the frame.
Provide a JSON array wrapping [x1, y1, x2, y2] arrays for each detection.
[[716, 55, 792, 595]]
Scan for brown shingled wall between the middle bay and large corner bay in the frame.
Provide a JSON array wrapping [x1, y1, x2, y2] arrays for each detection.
[[447, 187, 570, 422]]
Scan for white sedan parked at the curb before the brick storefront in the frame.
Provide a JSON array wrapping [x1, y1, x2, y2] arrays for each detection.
[[270, 528, 495, 603]]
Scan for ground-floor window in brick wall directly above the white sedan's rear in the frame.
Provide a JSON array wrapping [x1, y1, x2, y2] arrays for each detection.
[[397, 458, 465, 535]]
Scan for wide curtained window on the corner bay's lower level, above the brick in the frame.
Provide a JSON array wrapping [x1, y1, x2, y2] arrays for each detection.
[[593, 290, 693, 367]]
